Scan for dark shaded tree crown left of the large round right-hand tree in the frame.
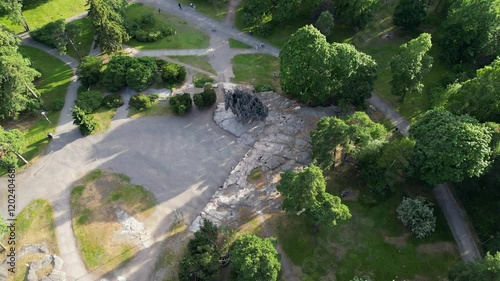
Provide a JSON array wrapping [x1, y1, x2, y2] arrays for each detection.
[[354, 138, 415, 193]]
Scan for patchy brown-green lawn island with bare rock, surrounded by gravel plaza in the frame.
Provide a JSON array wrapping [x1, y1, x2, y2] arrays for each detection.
[[71, 169, 156, 275]]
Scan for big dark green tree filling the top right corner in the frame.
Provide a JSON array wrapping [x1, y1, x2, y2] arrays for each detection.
[[439, 0, 500, 63]]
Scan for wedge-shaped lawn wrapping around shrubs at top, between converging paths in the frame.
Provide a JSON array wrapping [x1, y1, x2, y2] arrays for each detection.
[[126, 3, 210, 50]]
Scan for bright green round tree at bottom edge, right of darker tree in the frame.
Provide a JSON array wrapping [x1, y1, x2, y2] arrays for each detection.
[[231, 235, 281, 281]]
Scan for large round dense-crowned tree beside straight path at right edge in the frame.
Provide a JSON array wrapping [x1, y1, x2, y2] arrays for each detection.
[[410, 109, 492, 185]]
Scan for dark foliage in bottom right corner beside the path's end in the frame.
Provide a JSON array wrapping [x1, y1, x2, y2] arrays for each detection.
[[448, 252, 500, 281]]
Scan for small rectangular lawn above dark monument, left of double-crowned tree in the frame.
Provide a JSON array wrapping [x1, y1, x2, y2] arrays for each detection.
[[232, 54, 279, 89]]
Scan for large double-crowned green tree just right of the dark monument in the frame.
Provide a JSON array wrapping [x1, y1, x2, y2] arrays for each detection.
[[280, 25, 377, 106]]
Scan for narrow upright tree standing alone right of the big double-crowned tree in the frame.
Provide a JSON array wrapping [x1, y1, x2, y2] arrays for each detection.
[[390, 33, 432, 101]]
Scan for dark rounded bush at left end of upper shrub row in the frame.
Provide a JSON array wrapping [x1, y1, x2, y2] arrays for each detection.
[[102, 56, 135, 92]]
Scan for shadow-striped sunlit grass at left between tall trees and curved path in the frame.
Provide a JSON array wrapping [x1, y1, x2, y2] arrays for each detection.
[[13, 46, 73, 166]]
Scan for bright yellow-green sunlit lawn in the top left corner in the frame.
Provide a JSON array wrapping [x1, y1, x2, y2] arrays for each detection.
[[0, 0, 87, 33]]
